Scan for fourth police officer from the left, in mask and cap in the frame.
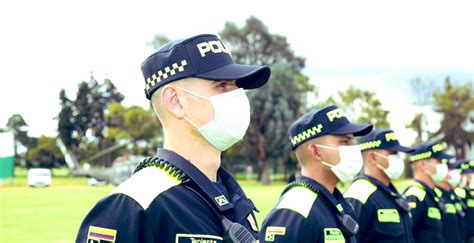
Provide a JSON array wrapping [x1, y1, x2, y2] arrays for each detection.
[[404, 142, 448, 242]]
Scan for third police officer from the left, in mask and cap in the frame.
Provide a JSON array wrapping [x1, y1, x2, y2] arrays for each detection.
[[344, 129, 413, 243]]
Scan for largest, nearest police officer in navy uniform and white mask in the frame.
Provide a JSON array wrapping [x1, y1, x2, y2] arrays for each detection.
[[76, 35, 270, 243]]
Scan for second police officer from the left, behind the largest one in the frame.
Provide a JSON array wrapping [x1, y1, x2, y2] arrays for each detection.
[[260, 106, 372, 242]]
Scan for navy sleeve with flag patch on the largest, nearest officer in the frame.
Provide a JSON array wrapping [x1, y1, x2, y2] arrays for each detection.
[[76, 194, 153, 243]]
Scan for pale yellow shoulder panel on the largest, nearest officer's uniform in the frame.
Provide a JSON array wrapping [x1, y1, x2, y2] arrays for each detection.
[[111, 167, 181, 209]]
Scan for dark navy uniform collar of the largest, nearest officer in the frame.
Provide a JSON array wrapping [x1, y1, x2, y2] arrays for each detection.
[[156, 148, 239, 211]]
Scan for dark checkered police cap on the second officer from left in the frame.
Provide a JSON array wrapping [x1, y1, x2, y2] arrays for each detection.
[[288, 105, 373, 150]]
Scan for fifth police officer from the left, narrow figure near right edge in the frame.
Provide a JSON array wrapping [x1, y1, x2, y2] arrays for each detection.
[[433, 158, 465, 242]]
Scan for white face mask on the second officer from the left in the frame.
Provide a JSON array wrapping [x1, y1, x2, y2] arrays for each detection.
[[316, 144, 364, 183]]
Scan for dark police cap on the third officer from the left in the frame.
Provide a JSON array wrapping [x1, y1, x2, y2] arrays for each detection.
[[358, 129, 414, 153]]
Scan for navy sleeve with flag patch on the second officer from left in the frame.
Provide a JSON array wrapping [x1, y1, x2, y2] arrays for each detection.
[[259, 209, 319, 243]]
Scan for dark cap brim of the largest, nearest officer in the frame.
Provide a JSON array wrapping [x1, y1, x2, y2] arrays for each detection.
[[194, 64, 271, 89]]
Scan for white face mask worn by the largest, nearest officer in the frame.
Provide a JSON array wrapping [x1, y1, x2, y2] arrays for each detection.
[[178, 87, 250, 151]]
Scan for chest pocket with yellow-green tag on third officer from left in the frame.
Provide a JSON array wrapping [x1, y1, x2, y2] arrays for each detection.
[[374, 209, 404, 236]]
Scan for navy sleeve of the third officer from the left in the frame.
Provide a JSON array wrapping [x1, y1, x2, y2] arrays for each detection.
[[346, 198, 376, 242]]
